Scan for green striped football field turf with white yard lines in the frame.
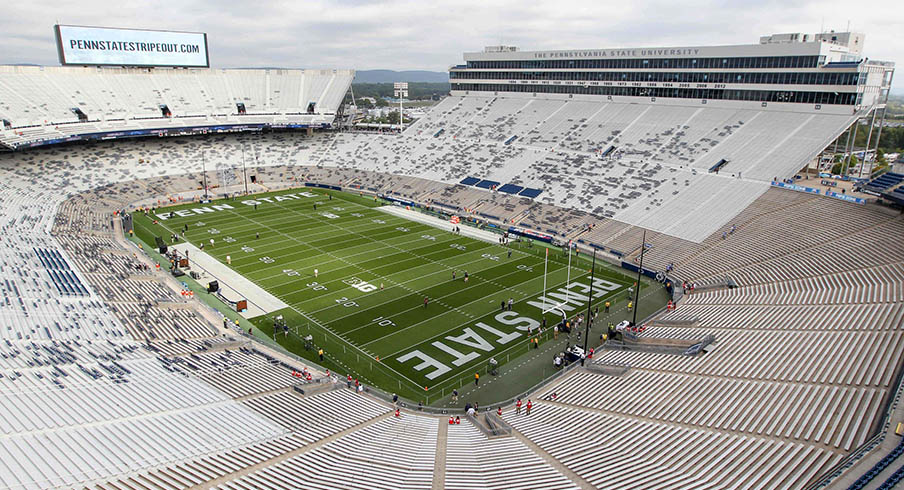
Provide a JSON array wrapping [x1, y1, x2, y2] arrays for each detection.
[[134, 188, 656, 399]]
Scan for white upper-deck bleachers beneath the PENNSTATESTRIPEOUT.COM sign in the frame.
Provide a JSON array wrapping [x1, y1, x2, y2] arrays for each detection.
[[0, 66, 354, 148]]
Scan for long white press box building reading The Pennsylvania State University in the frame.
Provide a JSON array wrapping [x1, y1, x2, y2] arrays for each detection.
[[449, 32, 894, 114]]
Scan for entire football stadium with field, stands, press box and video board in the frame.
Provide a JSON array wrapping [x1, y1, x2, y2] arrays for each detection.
[[0, 19, 904, 490]]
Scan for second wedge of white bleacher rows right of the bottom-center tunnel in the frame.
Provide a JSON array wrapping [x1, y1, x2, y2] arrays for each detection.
[[547, 370, 884, 451]]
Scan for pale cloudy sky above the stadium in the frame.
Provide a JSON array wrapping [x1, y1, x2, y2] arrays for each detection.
[[0, 0, 904, 92]]
